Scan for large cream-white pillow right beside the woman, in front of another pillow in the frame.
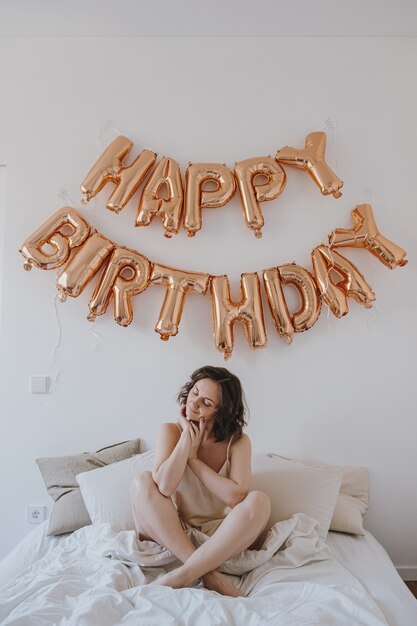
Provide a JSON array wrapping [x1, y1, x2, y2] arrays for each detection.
[[252, 454, 343, 539]]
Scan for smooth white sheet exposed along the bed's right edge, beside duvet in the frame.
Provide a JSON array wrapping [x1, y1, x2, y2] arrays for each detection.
[[327, 531, 417, 626]]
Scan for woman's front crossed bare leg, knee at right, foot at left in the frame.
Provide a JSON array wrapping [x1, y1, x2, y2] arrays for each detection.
[[151, 491, 271, 595]]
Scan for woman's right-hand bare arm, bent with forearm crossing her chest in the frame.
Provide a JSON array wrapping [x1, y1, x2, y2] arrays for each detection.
[[188, 435, 252, 508]]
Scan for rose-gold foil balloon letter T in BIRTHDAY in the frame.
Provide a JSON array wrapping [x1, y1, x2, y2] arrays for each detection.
[[151, 264, 210, 341]]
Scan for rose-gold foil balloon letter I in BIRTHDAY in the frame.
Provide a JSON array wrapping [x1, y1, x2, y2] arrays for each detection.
[[56, 232, 115, 302]]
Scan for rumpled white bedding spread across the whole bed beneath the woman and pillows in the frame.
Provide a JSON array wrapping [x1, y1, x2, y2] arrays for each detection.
[[0, 522, 417, 626]]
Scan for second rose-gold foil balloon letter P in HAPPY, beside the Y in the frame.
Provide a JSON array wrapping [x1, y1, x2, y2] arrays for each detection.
[[235, 157, 286, 237]]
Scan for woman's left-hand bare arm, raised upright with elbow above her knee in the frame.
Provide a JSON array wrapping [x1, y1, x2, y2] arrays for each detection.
[[152, 418, 191, 498]]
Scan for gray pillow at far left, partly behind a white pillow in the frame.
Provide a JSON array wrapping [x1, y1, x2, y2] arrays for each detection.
[[36, 439, 140, 535]]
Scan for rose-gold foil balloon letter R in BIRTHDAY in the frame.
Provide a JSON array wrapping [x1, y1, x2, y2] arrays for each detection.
[[88, 246, 151, 326]]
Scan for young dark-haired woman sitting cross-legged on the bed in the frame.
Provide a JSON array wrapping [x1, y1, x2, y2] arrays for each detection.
[[131, 366, 271, 596]]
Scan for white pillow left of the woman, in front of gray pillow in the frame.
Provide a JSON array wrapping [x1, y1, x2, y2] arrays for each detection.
[[76, 450, 153, 530]]
